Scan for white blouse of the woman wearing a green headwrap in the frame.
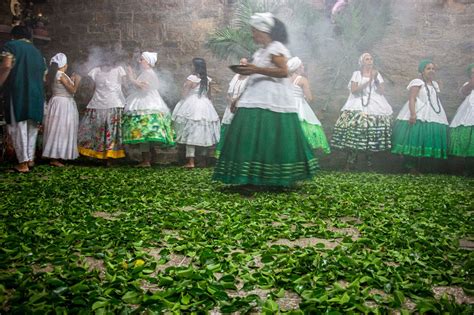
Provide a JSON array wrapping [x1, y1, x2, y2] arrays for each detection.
[[397, 79, 448, 125]]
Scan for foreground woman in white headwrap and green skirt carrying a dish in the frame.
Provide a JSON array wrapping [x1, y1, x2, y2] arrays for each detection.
[[213, 13, 318, 186]]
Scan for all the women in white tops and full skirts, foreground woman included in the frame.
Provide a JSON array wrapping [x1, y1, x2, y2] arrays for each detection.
[[3, 13, 474, 186]]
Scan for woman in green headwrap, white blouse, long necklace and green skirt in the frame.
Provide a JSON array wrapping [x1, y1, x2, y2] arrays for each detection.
[[392, 59, 448, 173]]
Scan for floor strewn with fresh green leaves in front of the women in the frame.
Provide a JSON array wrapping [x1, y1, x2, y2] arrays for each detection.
[[0, 166, 474, 314]]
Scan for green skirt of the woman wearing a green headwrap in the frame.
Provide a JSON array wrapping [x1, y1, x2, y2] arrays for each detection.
[[392, 120, 448, 159]]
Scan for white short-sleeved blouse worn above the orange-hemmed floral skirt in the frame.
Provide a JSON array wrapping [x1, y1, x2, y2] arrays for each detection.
[[87, 66, 127, 109]]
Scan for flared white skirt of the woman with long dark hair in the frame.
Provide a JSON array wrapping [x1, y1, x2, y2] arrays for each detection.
[[172, 94, 220, 147]]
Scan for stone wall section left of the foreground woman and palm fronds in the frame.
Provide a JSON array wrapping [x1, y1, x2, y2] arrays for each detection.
[[30, 0, 233, 107]]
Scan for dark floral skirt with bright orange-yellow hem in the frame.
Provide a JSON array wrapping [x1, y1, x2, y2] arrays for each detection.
[[78, 108, 125, 159]]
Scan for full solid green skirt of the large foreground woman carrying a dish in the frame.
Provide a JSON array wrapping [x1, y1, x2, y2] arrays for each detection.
[[213, 108, 318, 186]]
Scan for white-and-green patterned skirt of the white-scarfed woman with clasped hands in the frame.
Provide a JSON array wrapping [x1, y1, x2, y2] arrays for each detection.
[[331, 111, 392, 152]]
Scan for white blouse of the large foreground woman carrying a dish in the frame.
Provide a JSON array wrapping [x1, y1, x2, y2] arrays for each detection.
[[237, 41, 297, 113]]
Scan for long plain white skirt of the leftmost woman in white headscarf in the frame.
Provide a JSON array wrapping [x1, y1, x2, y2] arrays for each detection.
[[43, 96, 79, 160]]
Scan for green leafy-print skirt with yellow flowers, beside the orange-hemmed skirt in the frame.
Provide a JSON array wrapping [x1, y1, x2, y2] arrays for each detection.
[[122, 113, 175, 146]]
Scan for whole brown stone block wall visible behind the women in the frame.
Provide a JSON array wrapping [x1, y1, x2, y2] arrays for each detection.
[[0, 0, 474, 173]]
